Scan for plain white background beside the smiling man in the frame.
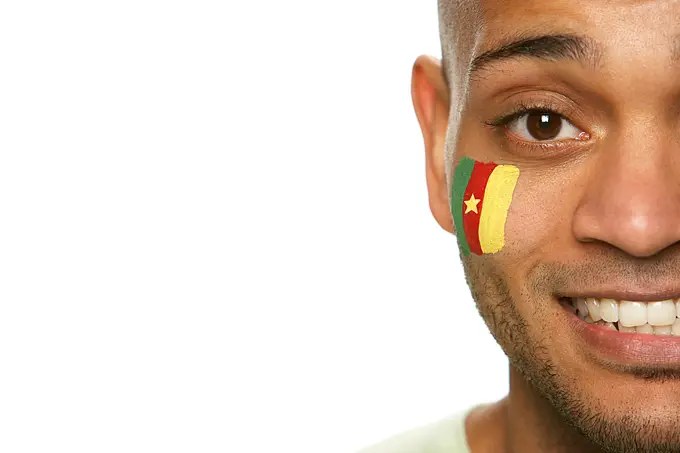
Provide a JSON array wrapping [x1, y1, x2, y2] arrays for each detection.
[[0, 0, 507, 453]]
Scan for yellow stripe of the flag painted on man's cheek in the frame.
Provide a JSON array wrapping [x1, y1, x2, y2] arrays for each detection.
[[479, 165, 519, 253]]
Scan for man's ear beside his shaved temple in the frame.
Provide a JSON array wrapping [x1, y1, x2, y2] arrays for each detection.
[[411, 55, 453, 233]]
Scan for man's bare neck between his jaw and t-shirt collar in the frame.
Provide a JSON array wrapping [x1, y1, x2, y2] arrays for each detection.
[[466, 366, 603, 453]]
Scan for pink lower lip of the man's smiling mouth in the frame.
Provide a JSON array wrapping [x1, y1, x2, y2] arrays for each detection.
[[567, 304, 680, 366]]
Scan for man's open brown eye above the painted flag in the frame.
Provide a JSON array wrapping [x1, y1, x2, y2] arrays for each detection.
[[507, 111, 583, 142]]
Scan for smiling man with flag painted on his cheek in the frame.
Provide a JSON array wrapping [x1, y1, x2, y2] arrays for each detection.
[[368, 0, 680, 453]]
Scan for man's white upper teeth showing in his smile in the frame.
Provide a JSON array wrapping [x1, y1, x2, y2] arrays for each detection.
[[572, 297, 680, 334]]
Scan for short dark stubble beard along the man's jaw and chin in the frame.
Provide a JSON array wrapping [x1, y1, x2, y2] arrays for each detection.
[[461, 257, 680, 453]]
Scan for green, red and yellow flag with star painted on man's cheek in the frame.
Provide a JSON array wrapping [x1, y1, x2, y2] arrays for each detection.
[[451, 157, 519, 256]]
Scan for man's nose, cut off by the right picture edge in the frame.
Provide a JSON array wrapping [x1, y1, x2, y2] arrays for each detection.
[[572, 131, 680, 257]]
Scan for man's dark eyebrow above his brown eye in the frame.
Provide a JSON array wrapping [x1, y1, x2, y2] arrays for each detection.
[[470, 35, 602, 77]]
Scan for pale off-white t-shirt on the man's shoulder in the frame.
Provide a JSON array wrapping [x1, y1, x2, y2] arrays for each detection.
[[359, 408, 474, 453]]
